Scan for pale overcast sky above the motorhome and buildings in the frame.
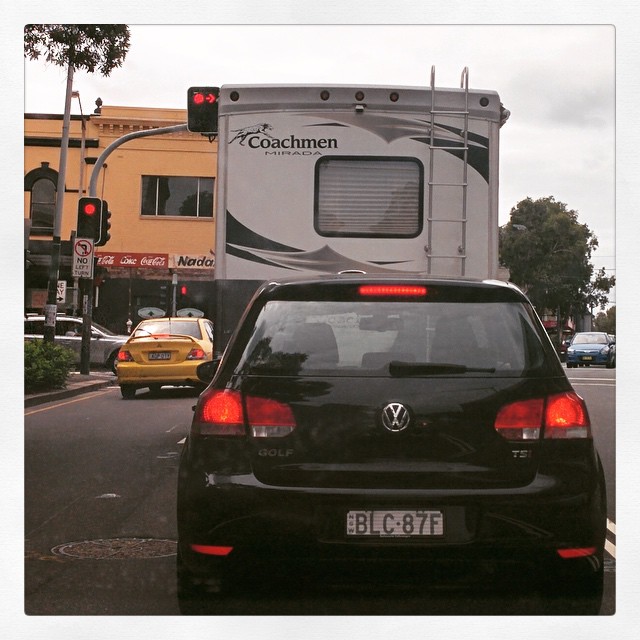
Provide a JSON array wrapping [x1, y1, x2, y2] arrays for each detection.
[[25, 24, 616, 302]]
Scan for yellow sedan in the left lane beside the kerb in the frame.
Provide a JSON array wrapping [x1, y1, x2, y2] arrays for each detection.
[[116, 317, 213, 400]]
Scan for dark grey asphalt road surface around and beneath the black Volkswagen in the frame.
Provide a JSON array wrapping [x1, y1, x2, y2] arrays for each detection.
[[24, 369, 616, 628]]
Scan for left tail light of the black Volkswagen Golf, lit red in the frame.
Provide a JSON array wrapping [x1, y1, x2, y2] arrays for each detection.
[[192, 389, 296, 438]]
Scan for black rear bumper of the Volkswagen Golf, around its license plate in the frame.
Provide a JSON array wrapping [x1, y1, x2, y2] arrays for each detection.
[[178, 464, 606, 573]]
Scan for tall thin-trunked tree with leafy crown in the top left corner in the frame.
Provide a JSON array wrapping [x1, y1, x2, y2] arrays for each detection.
[[24, 24, 130, 348]]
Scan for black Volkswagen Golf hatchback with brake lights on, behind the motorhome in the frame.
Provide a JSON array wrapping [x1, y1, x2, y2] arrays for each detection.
[[178, 275, 606, 597]]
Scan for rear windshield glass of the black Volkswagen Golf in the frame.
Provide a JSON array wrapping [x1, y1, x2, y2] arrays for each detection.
[[239, 300, 545, 376]]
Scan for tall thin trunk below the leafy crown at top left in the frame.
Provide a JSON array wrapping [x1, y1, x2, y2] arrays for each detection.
[[43, 64, 73, 344]]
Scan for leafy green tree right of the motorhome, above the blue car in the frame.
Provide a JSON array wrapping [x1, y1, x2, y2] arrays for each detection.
[[500, 197, 615, 336]]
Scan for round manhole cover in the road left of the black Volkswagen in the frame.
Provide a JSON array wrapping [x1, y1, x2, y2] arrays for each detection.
[[51, 538, 177, 560]]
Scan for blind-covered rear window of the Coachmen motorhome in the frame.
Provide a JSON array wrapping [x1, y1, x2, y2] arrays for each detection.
[[314, 157, 424, 238]]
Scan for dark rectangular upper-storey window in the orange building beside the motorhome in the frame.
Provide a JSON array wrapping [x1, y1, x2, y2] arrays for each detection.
[[141, 176, 213, 218]]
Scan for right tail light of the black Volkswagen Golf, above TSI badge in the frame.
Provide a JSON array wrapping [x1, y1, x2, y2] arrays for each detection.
[[494, 392, 591, 440]]
